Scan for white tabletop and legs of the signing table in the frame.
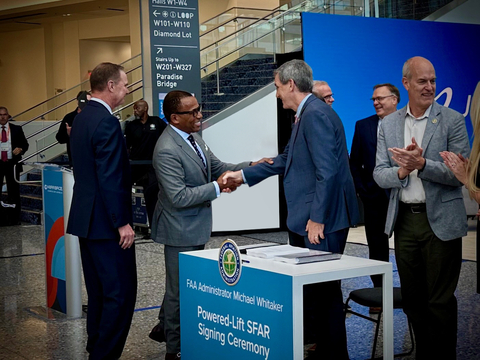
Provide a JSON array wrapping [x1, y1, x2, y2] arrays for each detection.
[[182, 246, 393, 360]]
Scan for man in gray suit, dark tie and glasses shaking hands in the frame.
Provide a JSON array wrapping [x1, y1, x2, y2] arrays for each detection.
[[150, 91, 268, 359]]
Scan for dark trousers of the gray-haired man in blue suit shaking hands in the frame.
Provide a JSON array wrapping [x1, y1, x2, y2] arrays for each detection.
[[289, 228, 349, 359]]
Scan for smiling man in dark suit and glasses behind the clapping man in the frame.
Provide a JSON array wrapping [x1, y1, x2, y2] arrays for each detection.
[[350, 84, 400, 296]]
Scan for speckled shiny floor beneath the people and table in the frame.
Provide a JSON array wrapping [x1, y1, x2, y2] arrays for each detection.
[[0, 225, 480, 360]]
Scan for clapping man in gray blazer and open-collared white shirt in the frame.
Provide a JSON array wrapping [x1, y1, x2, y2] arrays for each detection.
[[373, 57, 470, 359]]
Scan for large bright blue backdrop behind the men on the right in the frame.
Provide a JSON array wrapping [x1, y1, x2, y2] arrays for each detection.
[[302, 13, 480, 149]]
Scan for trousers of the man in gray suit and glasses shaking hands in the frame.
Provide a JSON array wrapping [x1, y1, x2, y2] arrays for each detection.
[[158, 245, 205, 354]]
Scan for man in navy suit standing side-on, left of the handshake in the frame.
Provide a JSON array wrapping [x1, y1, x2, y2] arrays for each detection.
[[67, 63, 137, 360]]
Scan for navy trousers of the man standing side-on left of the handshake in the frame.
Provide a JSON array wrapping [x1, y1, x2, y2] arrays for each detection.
[[80, 238, 137, 360]]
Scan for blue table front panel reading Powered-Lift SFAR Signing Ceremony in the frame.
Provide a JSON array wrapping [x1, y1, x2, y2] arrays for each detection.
[[179, 254, 293, 360]]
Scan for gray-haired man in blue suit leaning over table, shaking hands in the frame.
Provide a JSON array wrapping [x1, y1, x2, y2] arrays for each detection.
[[224, 60, 358, 359]]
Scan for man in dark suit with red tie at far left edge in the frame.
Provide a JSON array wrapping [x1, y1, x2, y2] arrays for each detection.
[[0, 106, 28, 224]]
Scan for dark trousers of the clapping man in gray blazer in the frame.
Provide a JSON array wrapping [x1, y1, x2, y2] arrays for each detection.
[[395, 209, 462, 360]]
